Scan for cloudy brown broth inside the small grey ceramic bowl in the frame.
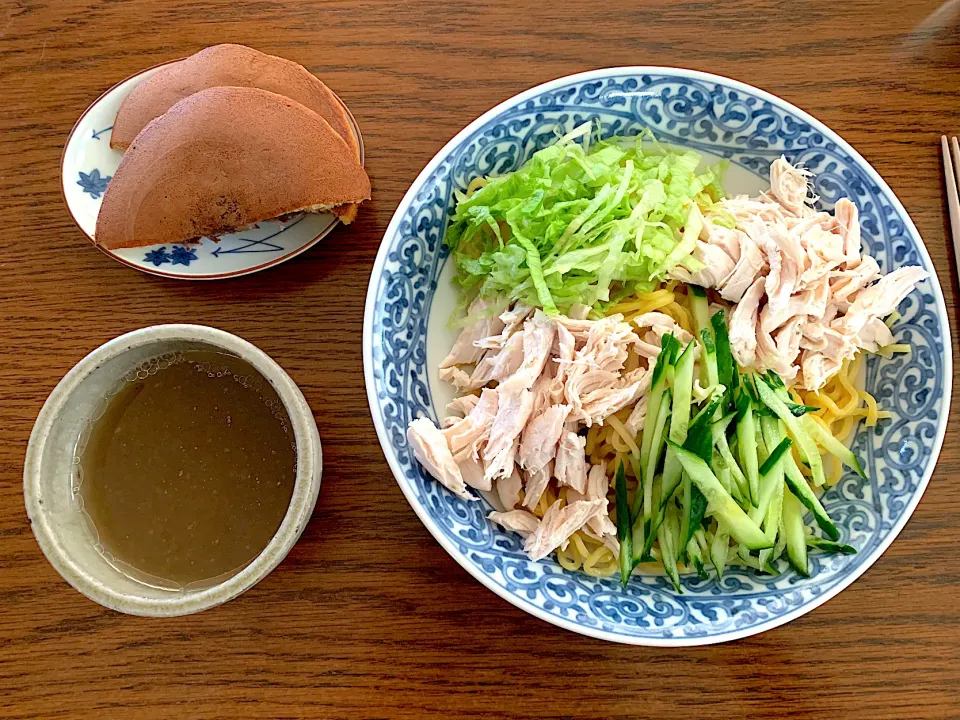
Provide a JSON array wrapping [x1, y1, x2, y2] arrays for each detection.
[[74, 350, 296, 588]]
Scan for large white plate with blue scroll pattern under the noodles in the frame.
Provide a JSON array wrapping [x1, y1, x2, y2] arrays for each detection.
[[363, 67, 952, 646]]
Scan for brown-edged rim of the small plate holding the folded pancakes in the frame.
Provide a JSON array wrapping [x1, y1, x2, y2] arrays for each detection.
[[60, 55, 366, 280]]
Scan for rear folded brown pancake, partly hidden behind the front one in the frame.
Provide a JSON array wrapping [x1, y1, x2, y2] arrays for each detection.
[[110, 44, 360, 157]]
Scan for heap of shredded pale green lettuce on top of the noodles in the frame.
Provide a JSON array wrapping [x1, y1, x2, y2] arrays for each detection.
[[445, 123, 723, 314]]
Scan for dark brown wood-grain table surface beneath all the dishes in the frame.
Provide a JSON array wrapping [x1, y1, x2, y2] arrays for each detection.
[[0, 0, 960, 719]]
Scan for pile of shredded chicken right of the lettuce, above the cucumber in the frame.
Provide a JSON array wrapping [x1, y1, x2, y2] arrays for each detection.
[[671, 158, 927, 390]]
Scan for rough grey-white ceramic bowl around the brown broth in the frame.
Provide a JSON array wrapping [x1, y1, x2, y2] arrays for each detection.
[[23, 325, 322, 616]]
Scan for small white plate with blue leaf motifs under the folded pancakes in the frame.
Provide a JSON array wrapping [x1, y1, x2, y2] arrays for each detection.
[[60, 60, 363, 280]]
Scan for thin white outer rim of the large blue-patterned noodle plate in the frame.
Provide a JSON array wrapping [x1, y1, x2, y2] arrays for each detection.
[[363, 65, 953, 647]]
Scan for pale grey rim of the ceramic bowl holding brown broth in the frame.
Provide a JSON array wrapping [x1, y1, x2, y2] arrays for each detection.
[[23, 324, 323, 617]]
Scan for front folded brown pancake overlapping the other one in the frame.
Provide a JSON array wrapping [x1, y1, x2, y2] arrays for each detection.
[[95, 87, 370, 249]]
